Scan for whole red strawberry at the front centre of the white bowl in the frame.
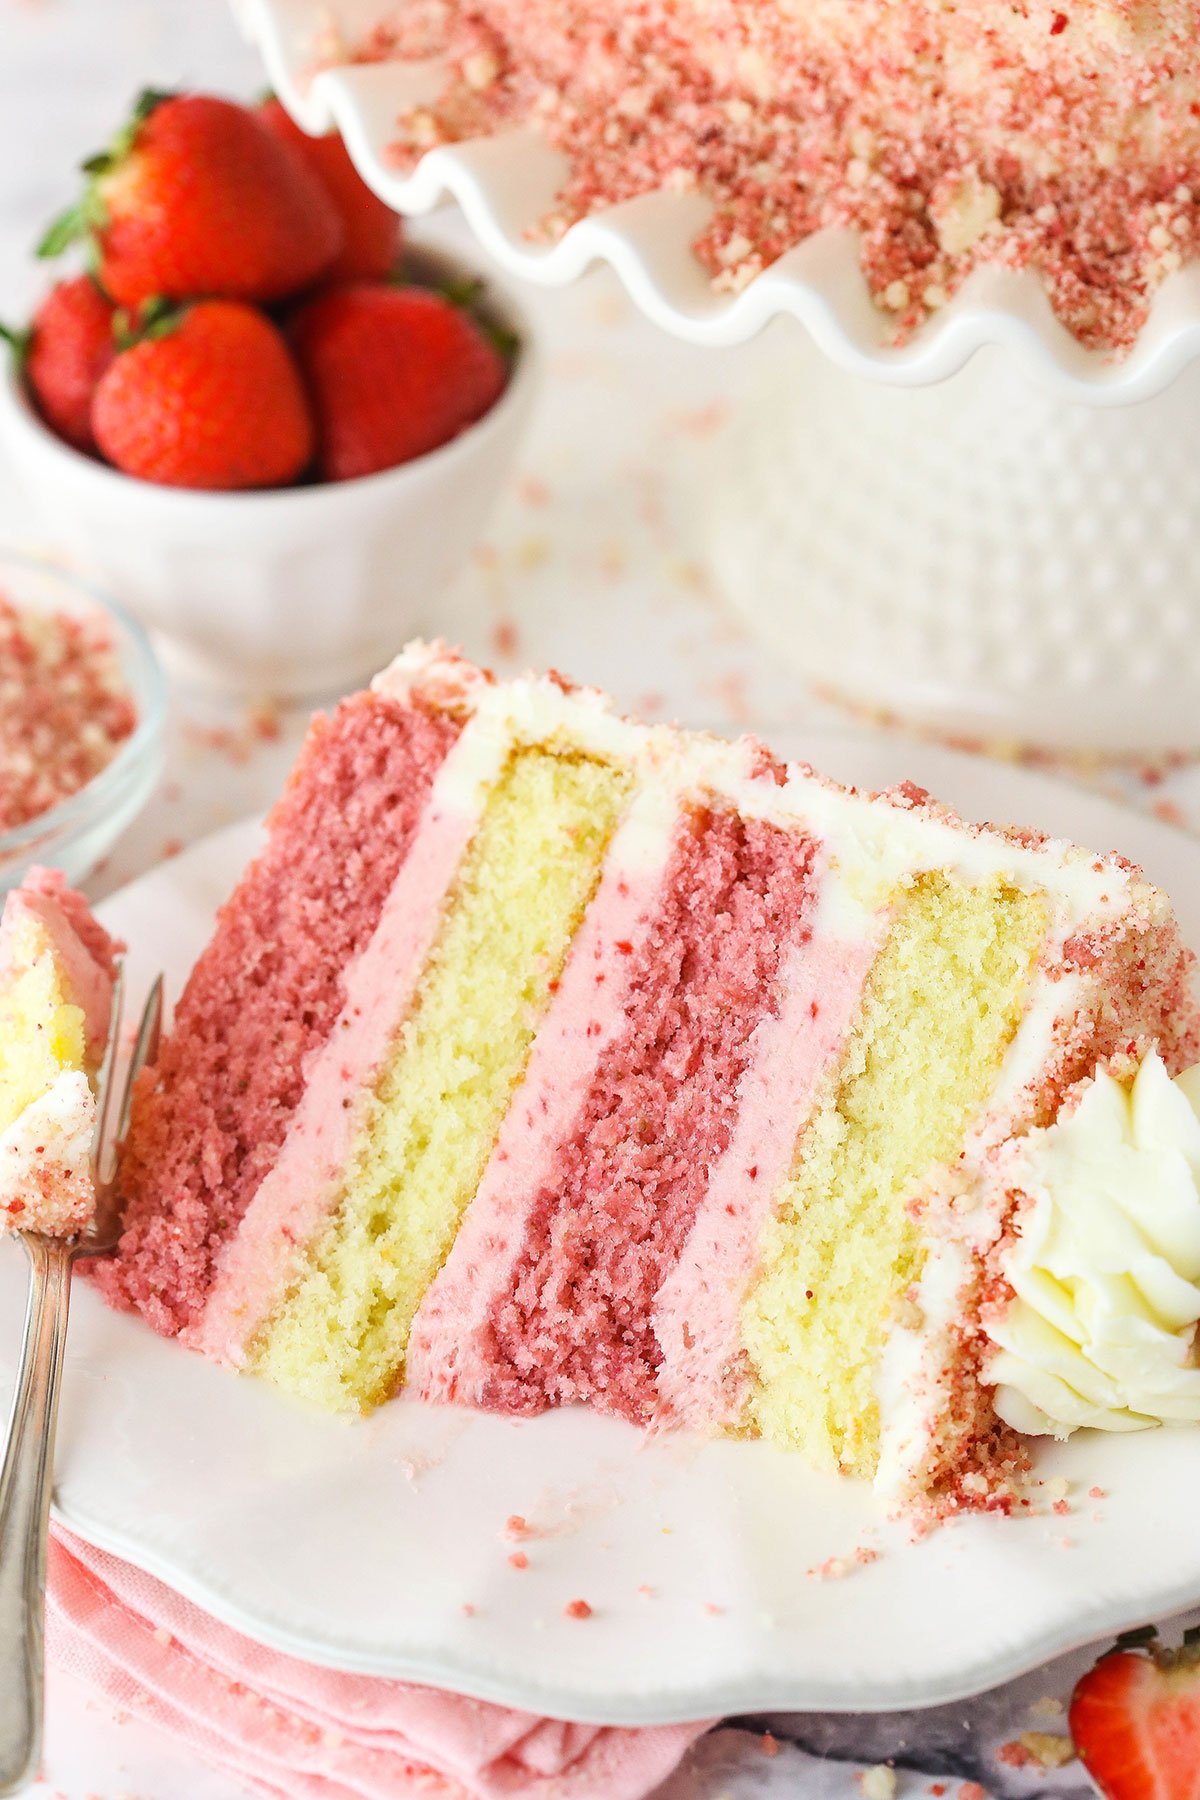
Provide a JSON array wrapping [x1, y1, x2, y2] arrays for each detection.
[[92, 301, 313, 488]]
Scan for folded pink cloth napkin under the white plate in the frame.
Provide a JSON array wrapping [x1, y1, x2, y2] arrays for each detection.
[[47, 1526, 705, 1800]]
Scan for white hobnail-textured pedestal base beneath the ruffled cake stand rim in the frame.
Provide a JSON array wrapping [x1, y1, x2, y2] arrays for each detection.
[[705, 329, 1200, 754]]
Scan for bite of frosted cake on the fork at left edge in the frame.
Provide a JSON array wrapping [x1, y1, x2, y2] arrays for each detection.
[[0, 869, 119, 1237]]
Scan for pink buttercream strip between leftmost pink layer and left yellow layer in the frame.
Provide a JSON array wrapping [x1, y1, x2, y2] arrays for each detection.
[[185, 799, 479, 1364]]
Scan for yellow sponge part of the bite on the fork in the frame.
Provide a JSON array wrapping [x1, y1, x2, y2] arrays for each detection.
[[0, 918, 86, 1130]]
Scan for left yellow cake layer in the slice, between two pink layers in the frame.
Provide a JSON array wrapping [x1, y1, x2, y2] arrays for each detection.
[[252, 749, 630, 1409]]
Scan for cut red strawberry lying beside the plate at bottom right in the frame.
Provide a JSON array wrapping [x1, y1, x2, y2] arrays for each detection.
[[1070, 1633, 1200, 1800]]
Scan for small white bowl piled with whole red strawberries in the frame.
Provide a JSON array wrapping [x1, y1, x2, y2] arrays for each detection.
[[0, 94, 536, 697]]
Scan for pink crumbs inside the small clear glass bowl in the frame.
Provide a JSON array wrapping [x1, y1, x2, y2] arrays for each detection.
[[0, 596, 137, 832]]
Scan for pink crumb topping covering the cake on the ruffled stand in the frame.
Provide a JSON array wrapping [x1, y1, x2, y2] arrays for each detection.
[[367, 0, 1200, 349]]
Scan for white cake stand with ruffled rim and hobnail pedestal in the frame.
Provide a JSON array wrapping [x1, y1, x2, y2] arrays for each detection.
[[236, 0, 1200, 754]]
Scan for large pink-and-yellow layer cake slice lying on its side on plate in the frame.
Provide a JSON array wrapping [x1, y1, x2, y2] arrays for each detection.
[[99, 644, 1200, 1505]]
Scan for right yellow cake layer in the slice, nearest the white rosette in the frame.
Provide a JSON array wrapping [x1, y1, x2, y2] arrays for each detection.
[[741, 875, 1047, 1476]]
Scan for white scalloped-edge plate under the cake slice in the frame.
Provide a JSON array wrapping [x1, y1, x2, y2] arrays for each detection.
[[14, 733, 1200, 1723]]
